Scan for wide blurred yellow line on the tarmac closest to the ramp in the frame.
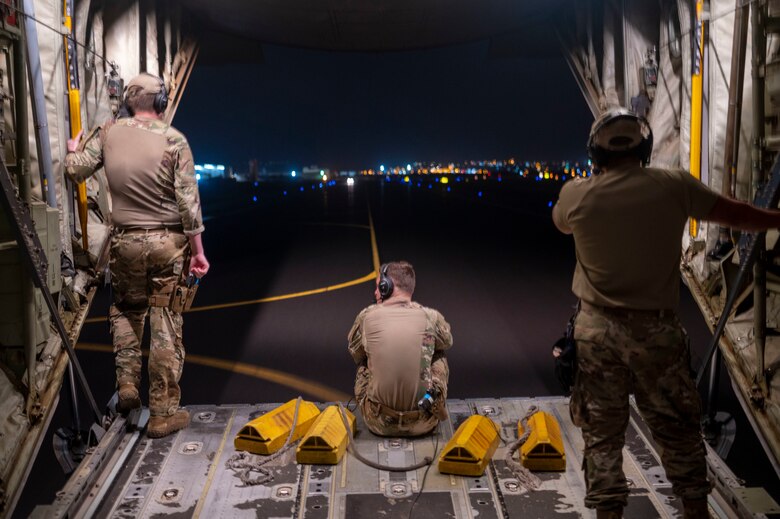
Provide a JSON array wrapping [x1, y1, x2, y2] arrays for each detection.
[[76, 342, 352, 402]]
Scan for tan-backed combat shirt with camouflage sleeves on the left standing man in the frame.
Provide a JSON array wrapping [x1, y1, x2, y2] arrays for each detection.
[[65, 117, 204, 235]]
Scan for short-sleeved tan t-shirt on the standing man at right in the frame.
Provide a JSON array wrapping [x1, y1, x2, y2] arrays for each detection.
[[553, 166, 718, 309]]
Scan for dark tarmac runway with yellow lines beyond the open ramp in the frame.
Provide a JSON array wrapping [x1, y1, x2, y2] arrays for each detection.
[[16, 174, 777, 517]]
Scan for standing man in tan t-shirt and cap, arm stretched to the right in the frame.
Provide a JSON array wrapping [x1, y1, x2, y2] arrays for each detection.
[[553, 109, 780, 519]]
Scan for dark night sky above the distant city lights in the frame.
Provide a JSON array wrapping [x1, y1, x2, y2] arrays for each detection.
[[174, 41, 591, 171]]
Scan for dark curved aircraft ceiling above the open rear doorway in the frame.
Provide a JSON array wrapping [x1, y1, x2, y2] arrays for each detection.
[[177, 0, 571, 57]]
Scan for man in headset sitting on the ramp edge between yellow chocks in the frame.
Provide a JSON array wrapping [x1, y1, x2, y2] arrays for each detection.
[[348, 261, 452, 436]]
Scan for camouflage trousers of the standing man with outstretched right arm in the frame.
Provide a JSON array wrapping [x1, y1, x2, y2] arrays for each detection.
[[570, 302, 711, 509]]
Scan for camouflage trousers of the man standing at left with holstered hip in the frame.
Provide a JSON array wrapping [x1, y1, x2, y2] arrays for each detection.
[[110, 230, 190, 416]]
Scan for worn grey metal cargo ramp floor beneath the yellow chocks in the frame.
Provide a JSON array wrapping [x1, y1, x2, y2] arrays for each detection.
[[27, 397, 780, 519]]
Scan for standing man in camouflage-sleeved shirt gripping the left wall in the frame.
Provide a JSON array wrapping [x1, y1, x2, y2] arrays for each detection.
[[65, 74, 209, 437]]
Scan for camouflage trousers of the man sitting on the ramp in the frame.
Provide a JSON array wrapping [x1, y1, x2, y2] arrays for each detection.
[[355, 355, 450, 437]]
